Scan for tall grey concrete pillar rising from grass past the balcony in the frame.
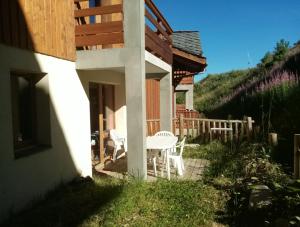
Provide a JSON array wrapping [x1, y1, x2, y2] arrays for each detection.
[[124, 0, 147, 179]]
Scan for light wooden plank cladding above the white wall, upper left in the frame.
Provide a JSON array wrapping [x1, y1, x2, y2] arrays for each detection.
[[0, 0, 76, 61]]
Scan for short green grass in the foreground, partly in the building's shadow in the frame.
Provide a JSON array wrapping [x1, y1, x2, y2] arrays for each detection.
[[4, 177, 225, 226]]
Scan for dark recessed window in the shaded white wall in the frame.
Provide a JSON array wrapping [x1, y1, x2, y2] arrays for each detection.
[[11, 73, 50, 158]]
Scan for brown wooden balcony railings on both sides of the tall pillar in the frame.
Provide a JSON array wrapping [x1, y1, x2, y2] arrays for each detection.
[[74, 0, 173, 64]]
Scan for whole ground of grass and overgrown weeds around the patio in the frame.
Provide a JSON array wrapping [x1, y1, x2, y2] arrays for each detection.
[[3, 141, 300, 226]]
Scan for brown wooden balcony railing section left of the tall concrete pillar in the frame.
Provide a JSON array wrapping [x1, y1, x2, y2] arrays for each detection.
[[74, 0, 124, 49]]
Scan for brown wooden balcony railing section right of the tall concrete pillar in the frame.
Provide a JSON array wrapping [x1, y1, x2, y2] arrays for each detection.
[[145, 0, 173, 64]]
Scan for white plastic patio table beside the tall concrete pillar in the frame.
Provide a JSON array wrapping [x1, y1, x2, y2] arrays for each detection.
[[146, 136, 178, 180]]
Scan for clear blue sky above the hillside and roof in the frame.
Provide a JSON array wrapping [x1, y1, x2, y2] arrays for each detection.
[[154, 0, 300, 79]]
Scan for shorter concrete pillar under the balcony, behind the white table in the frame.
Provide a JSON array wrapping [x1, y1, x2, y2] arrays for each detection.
[[159, 73, 173, 132]]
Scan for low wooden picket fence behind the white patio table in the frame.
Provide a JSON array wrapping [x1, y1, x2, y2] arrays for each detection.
[[147, 115, 254, 142]]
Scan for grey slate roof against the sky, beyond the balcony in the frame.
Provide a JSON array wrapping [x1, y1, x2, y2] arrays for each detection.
[[172, 31, 202, 56]]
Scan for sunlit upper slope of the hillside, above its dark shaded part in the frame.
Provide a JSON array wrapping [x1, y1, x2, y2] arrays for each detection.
[[194, 41, 300, 116]]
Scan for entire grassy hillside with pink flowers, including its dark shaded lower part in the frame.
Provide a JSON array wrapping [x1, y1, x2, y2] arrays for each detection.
[[194, 41, 300, 168]]
